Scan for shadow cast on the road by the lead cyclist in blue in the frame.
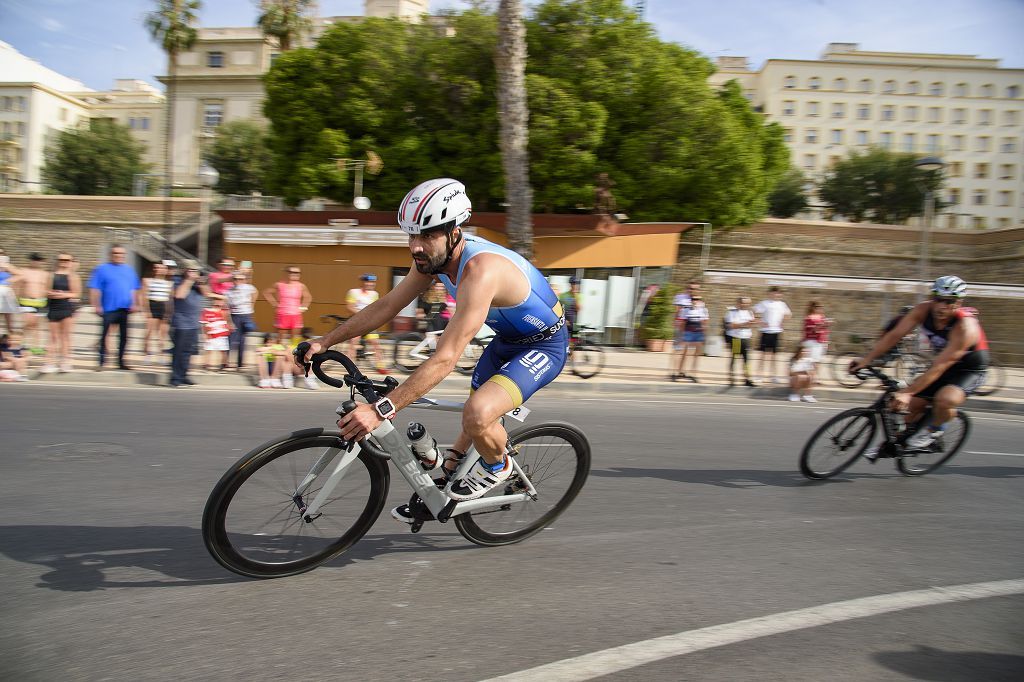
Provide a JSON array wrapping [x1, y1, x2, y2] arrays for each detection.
[[0, 525, 475, 592]]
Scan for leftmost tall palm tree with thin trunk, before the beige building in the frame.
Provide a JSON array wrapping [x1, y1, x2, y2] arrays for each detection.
[[143, 0, 201, 246]]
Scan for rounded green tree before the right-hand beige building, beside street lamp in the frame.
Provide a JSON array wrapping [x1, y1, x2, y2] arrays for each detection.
[[818, 147, 942, 224]]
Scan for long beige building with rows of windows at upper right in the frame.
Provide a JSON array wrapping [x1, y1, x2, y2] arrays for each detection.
[[711, 43, 1024, 229]]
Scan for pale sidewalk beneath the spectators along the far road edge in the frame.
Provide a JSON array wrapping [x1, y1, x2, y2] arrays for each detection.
[[18, 312, 1024, 414]]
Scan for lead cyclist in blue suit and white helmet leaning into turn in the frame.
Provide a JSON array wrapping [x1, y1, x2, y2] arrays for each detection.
[[306, 178, 568, 512]]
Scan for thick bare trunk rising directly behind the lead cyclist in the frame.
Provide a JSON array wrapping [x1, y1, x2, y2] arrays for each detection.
[[495, 0, 534, 259]]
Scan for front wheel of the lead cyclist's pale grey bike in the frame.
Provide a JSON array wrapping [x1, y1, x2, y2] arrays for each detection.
[[203, 429, 390, 578]]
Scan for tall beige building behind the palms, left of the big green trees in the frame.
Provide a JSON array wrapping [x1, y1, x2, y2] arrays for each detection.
[[159, 0, 428, 185]]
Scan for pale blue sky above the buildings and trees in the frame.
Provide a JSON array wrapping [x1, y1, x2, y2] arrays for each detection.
[[0, 0, 1024, 90]]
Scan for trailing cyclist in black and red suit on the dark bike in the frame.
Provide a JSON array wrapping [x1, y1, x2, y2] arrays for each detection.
[[850, 275, 988, 459]]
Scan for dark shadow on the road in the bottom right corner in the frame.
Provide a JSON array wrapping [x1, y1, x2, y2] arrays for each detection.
[[872, 644, 1024, 682]]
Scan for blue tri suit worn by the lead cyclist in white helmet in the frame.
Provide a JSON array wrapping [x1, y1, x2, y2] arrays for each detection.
[[438, 235, 568, 407]]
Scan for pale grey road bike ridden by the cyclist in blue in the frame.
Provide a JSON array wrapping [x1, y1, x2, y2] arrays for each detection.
[[203, 344, 591, 578]]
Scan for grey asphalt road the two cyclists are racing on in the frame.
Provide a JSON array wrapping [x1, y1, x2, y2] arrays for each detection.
[[0, 385, 1024, 682]]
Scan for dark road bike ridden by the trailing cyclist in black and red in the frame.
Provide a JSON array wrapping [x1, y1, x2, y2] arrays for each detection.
[[800, 367, 971, 479]]
